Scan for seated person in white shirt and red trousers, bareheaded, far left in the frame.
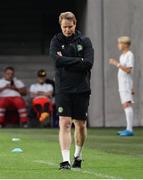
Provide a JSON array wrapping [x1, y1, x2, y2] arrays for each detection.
[[0, 67, 28, 127]]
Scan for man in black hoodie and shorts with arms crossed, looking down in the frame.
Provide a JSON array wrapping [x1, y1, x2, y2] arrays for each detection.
[[50, 12, 94, 169]]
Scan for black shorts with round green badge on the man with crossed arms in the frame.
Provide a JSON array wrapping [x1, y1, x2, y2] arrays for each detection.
[[56, 93, 90, 120]]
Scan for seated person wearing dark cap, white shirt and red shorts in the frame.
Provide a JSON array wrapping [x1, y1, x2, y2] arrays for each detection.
[[30, 69, 53, 123]]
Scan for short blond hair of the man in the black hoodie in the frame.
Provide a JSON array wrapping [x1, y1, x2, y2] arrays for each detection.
[[59, 12, 77, 24]]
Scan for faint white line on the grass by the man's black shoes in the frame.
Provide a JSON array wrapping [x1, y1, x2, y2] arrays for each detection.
[[33, 160, 121, 179]]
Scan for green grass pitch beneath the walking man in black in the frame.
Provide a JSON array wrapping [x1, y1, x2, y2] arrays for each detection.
[[0, 129, 143, 179]]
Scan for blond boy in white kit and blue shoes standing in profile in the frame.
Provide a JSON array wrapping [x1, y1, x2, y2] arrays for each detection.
[[109, 36, 134, 136]]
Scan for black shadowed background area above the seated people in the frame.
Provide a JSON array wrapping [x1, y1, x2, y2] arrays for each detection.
[[0, 0, 84, 55]]
